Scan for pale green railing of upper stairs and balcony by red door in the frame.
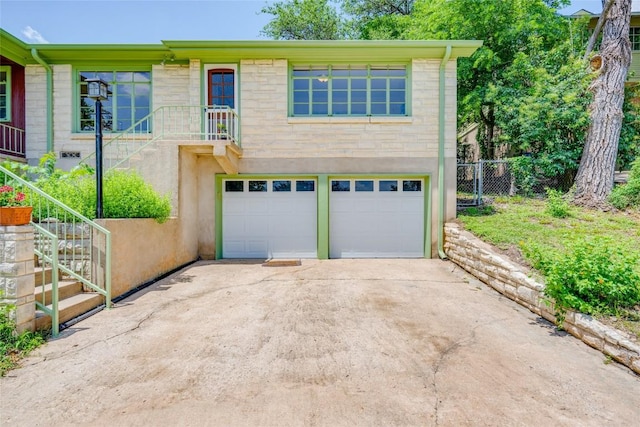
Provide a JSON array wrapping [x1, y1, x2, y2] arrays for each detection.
[[82, 105, 240, 170]]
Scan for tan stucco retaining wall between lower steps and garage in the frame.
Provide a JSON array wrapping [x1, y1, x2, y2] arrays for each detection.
[[96, 218, 198, 297]]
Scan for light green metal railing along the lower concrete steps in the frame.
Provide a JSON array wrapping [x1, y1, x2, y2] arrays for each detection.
[[0, 166, 111, 334]]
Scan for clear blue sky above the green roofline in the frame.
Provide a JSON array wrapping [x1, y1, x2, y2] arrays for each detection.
[[0, 0, 616, 44]]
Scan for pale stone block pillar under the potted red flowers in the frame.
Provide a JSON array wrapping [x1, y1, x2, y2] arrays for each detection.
[[0, 225, 36, 333]]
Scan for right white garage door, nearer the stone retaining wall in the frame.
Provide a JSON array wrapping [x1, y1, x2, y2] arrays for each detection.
[[329, 179, 425, 258]]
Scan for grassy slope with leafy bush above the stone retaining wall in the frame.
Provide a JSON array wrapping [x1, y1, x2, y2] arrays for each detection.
[[459, 199, 640, 329]]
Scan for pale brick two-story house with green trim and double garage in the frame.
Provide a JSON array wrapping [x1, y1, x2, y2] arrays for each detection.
[[0, 30, 481, 258]]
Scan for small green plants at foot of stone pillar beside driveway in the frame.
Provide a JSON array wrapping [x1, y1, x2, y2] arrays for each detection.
[[0, 304, 44, 376]]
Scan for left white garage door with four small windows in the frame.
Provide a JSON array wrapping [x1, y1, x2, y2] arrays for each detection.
[[222, 179, 317, 258]]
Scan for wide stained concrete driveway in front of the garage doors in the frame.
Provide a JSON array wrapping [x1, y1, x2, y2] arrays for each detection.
[[0, 260, 640, 426]]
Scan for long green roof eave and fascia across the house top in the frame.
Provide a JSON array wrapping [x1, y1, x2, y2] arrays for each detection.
[[0, 29, 482, 65]]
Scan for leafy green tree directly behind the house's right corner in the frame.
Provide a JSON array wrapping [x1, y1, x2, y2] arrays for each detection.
[[404, 0, 570, 159]]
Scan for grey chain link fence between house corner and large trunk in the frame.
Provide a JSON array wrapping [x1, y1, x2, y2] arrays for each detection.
[[457, 160, 573, 207]]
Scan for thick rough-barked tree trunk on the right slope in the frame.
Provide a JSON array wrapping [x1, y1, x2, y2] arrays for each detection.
[[574, 0, 631, 208]]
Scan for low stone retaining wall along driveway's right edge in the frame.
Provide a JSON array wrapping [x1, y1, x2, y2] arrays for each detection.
[[444, 223, 640, 374]]
